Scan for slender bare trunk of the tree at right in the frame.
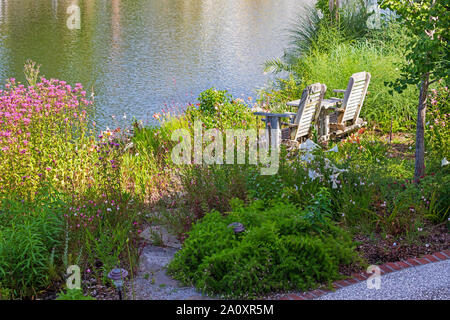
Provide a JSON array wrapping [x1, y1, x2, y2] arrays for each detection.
[[414, 73, 430, 182]]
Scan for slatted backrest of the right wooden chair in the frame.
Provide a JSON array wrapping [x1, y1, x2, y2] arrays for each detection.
[[342, 71, 370, 122]]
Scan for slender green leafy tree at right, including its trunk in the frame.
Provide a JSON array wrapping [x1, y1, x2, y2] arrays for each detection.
[[381, 0, 450, 181]]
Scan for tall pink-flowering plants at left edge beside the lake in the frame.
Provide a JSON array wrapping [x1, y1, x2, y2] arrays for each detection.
[[0, 78, 94, 196]]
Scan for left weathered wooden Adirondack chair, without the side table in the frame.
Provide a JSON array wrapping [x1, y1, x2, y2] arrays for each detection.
[[281, 83, 327, 142]]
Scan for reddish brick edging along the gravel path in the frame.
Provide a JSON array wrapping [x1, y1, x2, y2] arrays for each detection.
[[277, 250, 450, 300]]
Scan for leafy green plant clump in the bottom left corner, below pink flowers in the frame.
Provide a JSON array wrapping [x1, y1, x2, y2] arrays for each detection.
[[0, 190, 64, 297]]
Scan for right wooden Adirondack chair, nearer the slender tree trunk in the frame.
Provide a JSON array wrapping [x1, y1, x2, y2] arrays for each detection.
[[319, 72, 370, 140]]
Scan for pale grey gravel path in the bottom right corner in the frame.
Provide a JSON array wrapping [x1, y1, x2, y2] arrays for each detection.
[[316, 260, 450, 300]]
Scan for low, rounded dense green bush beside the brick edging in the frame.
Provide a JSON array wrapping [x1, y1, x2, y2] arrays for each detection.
[[169, 190, 356, 298]]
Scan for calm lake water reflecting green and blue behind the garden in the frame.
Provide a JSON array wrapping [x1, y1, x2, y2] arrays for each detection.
[[0, 0, 312, 126]]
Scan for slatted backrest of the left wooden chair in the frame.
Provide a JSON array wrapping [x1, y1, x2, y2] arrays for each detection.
[[294, 83, 327, 140]]
